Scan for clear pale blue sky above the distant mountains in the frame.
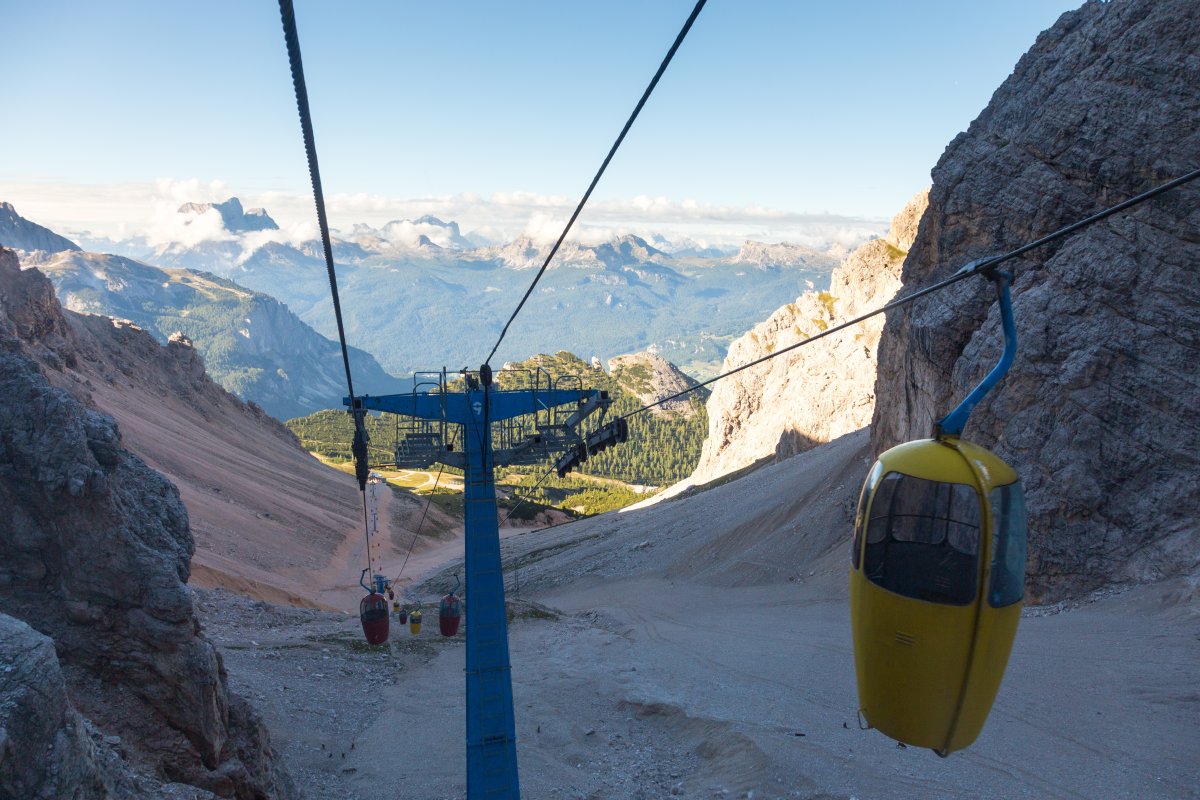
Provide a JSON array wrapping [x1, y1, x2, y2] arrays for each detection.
[[0, 0, 1078, 244]]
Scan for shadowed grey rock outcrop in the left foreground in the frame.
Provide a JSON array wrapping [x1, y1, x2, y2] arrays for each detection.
[[0, 249, 293, 799]]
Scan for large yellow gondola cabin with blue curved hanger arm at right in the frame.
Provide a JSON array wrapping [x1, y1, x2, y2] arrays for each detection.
[[850, 267, 1026, 756]]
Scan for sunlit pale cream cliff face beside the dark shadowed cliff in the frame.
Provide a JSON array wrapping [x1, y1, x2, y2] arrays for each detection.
[[690, 193, 925, 483]]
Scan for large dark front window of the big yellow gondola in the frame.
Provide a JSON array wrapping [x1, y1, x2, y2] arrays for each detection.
[[863, 473, 979, 606]]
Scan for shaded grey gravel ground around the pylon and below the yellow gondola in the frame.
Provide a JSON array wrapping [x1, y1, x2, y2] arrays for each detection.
[[202, 434, 1200, 800]]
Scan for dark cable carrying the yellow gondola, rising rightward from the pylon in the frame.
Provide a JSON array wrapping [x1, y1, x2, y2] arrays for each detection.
[[617, 168, 1200, 420]]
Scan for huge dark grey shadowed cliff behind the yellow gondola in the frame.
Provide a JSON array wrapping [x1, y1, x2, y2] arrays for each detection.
[[872, 0, 1200, 599]]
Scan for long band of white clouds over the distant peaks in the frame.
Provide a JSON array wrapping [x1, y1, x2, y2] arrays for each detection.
[[0, 179, 887, 247]]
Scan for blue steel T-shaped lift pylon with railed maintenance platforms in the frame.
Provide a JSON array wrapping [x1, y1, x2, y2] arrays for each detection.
[[343, 365, 610, 800]]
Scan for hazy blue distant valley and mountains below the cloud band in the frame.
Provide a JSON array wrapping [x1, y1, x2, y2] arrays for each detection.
[[49, 198, 854, 393]]
